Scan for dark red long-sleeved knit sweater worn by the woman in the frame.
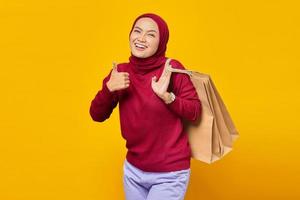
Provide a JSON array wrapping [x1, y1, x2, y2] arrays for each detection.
[[90, 60, 201, 172]]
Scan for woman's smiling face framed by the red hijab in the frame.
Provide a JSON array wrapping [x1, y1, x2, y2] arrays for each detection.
[[129, 17, 159, 58]]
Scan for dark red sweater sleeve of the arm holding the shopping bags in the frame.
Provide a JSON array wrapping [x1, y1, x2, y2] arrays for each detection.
[[166, 60, 202, 121]]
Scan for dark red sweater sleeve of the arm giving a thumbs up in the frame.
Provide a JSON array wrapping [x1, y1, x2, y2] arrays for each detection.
[[89, 70, 119, 122]]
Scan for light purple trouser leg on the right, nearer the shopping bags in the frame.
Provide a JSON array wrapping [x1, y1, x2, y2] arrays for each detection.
[[147, 169, 191, 200]]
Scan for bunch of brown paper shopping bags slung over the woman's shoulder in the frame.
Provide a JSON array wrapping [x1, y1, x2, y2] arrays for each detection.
[[166, 61, 239, 164]]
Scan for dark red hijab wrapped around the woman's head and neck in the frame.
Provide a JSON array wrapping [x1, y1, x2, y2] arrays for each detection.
[[129, 13, 169, 74]]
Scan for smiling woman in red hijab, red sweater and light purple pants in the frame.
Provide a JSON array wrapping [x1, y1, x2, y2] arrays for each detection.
[[90, 13, 201, 200]]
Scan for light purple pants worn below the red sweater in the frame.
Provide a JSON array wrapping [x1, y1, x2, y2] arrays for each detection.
[[123, 159, 191, 200]]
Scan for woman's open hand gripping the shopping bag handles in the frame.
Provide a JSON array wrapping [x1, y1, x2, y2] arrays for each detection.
[[151, 60, 172, 99]]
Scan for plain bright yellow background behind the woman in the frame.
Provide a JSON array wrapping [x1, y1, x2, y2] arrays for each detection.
[[0, 0, 300, 200]]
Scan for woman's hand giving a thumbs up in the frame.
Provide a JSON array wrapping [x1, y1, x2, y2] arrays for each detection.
[[106, 62, 130, 92]]
